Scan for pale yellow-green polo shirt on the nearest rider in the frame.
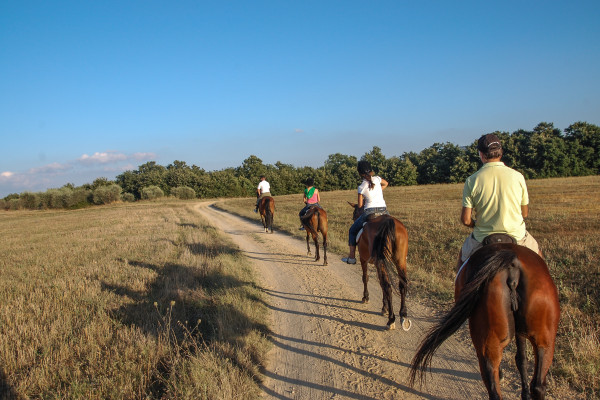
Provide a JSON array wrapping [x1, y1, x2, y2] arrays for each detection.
[[463, 161, 529, 242]]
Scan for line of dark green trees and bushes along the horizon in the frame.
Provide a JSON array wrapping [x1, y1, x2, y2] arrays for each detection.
[[0, 122, 600, 209]]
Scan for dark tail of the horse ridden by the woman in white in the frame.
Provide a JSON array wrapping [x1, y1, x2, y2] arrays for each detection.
[[371, 217, 408, 295]]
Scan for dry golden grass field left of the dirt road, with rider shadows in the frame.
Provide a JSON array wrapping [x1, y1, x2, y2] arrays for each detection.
[[0, 201, 269, 399]]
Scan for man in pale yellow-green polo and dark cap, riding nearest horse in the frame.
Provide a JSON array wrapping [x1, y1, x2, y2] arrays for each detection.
[[458, 134, 542, 266]]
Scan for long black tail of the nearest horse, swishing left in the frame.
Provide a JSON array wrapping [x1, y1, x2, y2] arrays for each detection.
[[410, 249, 520, 386]]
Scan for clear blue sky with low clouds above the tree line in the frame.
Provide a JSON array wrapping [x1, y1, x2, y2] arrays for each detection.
[[0, 0, 600, 197]]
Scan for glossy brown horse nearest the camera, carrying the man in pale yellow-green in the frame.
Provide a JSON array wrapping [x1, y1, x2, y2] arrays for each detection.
[[410, 243, 560, 399]]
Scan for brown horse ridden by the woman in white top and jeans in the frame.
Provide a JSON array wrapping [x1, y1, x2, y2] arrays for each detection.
[[348, 202, 412, 331]]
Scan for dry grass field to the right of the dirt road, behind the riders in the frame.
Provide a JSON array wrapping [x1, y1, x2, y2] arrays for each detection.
[[218, 176, 600, 399]]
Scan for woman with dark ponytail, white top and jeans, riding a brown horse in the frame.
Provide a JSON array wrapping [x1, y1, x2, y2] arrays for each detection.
[[342, 161, 388, 264]]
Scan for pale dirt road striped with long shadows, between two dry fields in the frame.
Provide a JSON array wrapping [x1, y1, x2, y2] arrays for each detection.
[[197, 203, 487, 400]]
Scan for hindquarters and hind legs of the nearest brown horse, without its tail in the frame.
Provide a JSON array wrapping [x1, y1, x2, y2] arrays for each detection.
[[469, 244, 560, 399]]
